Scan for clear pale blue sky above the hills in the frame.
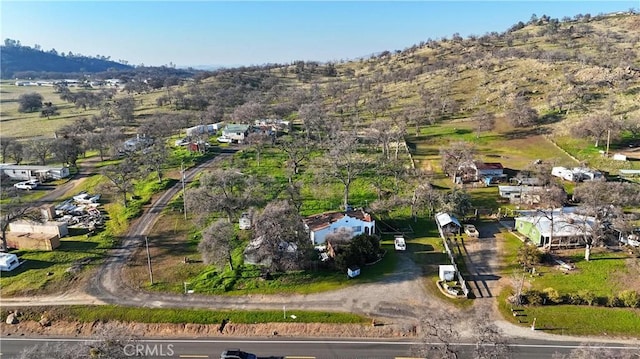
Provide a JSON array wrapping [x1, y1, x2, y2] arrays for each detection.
[[0, 0, 640, 66]]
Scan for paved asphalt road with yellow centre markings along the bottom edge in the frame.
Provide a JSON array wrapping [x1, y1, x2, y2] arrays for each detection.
[[2, 337, 640, 359]]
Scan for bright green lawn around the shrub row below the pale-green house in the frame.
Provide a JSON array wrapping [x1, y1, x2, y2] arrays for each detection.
[[498, 233, 640, 337]]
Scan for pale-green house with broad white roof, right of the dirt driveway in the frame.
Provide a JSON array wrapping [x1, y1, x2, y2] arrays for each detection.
[[515, 208, 595, 247]]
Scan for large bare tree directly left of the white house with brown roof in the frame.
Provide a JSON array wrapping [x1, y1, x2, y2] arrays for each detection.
[[254, 201, 313, 271]]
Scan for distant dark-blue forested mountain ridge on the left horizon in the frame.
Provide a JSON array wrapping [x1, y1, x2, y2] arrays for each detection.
[[0, 41, 134, 79]]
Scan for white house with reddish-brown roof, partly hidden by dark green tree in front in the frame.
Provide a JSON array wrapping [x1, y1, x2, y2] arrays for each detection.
[[304, 209, 376, 246]]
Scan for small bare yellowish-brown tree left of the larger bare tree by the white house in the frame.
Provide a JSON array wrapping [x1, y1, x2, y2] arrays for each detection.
[[198, 219, 235, 270]]
